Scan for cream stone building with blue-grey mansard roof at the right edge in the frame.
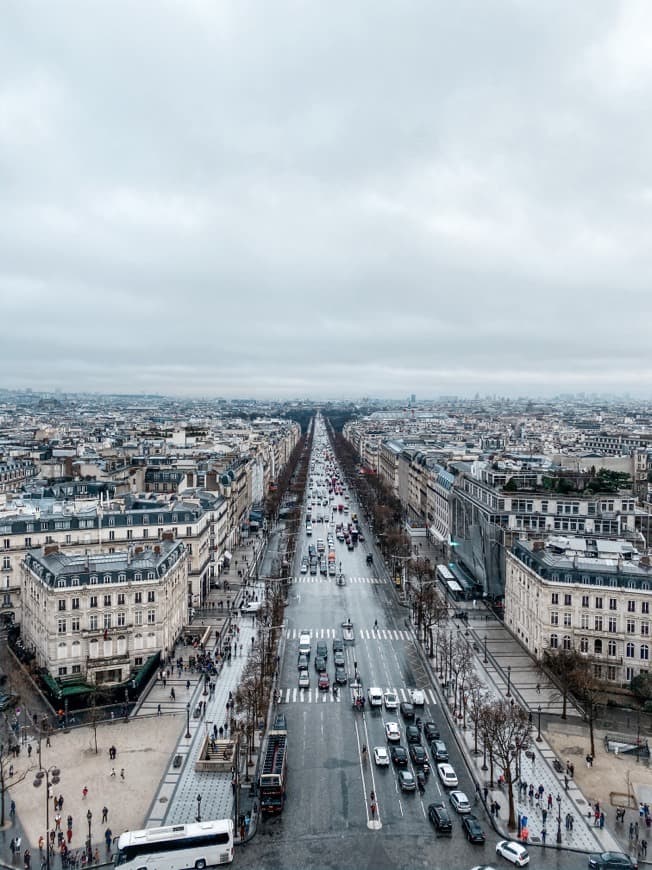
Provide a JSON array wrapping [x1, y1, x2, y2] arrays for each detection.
[[505, 536, 652, 686]]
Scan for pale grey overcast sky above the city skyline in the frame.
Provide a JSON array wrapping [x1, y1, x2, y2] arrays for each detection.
[[0, 0, 652, 398]]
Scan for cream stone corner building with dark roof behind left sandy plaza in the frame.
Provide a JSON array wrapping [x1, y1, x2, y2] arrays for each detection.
[[20, 541, 188, 688]]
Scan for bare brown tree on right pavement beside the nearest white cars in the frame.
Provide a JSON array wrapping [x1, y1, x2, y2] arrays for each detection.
[[483, 698, 530, 829]]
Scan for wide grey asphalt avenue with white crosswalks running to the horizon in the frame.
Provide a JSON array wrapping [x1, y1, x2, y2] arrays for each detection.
[[239, 424, 587, 870]]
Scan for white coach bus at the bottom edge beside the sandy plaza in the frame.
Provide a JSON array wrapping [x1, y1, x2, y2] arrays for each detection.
[[115, 819, 233, 870]]
